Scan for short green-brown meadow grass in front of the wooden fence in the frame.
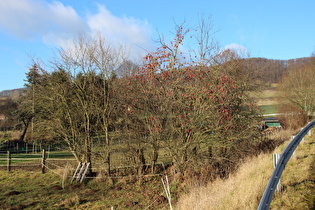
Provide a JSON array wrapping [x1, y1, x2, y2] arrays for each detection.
[[0, 171, 172, 209]]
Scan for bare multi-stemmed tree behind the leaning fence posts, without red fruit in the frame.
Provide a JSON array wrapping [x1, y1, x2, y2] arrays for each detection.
[[20, 34, 125, 175]]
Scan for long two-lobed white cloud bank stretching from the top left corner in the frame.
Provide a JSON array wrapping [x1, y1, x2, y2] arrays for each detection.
[[0, 0, 152, 60]]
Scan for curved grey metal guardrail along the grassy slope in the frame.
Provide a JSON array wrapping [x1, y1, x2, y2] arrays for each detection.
[[258, 120, 315, 210]]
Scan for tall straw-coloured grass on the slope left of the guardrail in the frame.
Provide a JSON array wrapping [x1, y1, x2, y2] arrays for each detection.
[[176, 131, 298, 210]]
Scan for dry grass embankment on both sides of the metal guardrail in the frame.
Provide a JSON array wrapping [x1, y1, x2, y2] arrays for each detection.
[[176, 130, 315, 210]]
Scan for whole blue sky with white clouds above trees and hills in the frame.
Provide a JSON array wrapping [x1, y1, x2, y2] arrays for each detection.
[[0, 0, 315, 91]]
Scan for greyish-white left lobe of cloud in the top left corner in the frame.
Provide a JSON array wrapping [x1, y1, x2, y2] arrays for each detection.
[[0, 0, 89, 44]]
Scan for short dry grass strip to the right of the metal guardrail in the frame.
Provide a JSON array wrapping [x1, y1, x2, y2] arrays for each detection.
[[270, 132, 315, 209]]
